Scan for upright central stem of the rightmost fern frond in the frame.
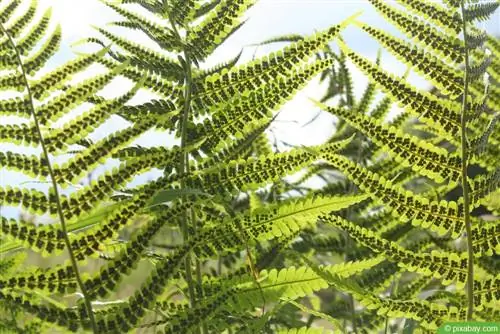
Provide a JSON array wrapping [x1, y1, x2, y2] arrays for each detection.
[[460, 1, 474, 321]]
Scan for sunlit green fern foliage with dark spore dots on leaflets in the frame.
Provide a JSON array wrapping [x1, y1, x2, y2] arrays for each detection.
[[0, 0, 500, 333]]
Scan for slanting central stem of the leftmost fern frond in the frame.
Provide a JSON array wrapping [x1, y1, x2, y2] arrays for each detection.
[[0, 22, 99, 334]]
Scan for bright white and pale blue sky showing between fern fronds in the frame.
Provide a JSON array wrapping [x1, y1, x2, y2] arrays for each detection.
[[0, 0, 500, 220]]
